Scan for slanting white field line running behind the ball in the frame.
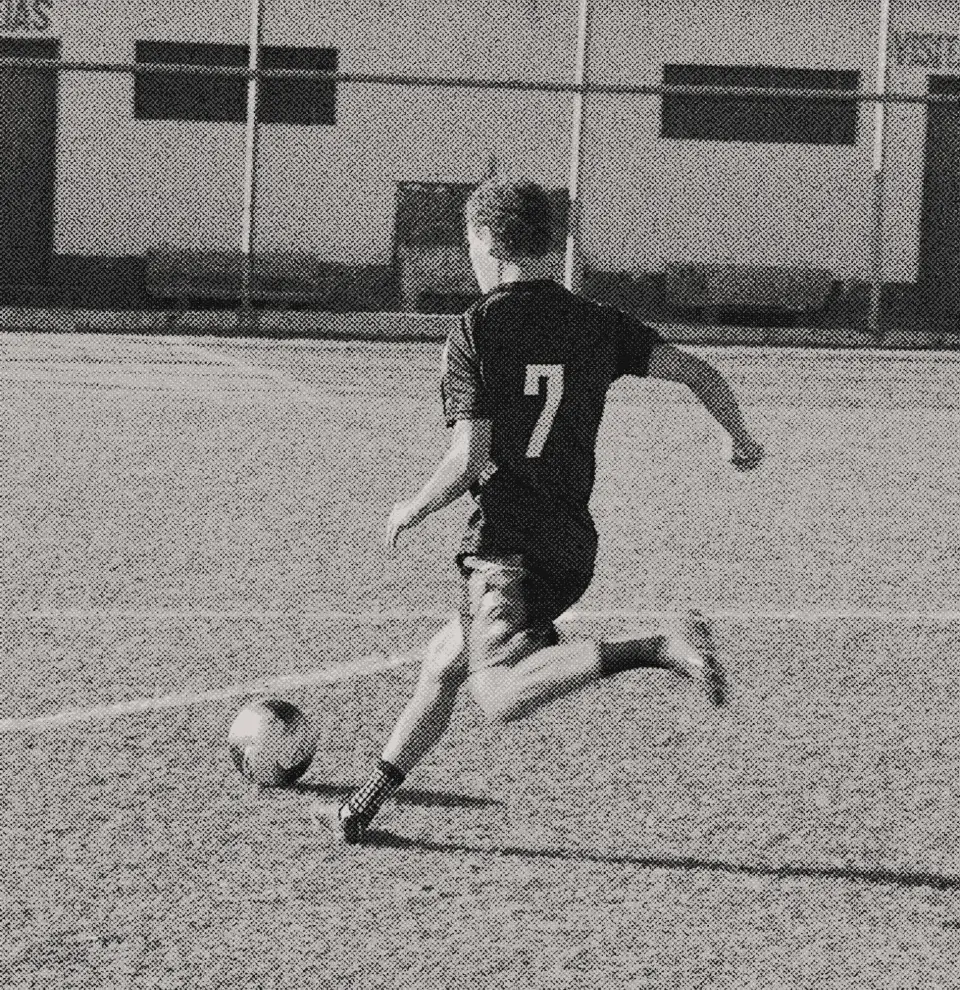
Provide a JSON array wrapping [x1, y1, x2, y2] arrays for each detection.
[[0, 654, 413, 735]]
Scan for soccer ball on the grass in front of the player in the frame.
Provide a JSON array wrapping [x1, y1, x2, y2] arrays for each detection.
[[227, 698, 317, 787]]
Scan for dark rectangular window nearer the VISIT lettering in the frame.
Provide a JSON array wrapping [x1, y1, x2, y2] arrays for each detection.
[[660, 65, 860, 144]]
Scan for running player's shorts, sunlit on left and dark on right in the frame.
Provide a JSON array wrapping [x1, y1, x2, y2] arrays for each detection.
[[460, 554, 593, 671]]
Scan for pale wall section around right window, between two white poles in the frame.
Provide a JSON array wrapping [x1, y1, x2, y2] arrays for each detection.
[[584, 0, 877, 276]]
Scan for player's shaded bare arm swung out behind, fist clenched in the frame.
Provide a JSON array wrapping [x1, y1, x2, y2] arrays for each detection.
[[647, 343, 763, 471]]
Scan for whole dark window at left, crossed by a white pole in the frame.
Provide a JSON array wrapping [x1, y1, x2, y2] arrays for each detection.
[[134, 41, 337, 124]]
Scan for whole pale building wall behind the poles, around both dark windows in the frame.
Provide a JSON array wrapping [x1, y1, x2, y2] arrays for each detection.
[[3, 0, 960, 280]]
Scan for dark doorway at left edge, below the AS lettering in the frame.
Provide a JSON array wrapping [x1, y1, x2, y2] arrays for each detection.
[[0, 38, 60, 285]]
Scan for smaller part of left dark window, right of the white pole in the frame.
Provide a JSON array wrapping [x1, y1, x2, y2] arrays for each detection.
[[260, 45, 337, 125]]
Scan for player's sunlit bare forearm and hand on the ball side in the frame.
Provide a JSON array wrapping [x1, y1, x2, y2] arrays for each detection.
[[384, 419, 491, 548]]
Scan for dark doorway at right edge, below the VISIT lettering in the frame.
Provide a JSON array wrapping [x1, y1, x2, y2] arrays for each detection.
[[918, 76, 960, 330]]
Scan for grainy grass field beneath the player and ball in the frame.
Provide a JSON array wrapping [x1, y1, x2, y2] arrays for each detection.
[[0, 334, 960, 990]]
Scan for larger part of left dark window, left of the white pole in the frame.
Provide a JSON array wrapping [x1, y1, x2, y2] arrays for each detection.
[[133, 41, 248, 122]]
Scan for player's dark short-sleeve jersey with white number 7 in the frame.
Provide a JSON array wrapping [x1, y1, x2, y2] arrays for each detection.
[[441, 280, 662, 567]]
